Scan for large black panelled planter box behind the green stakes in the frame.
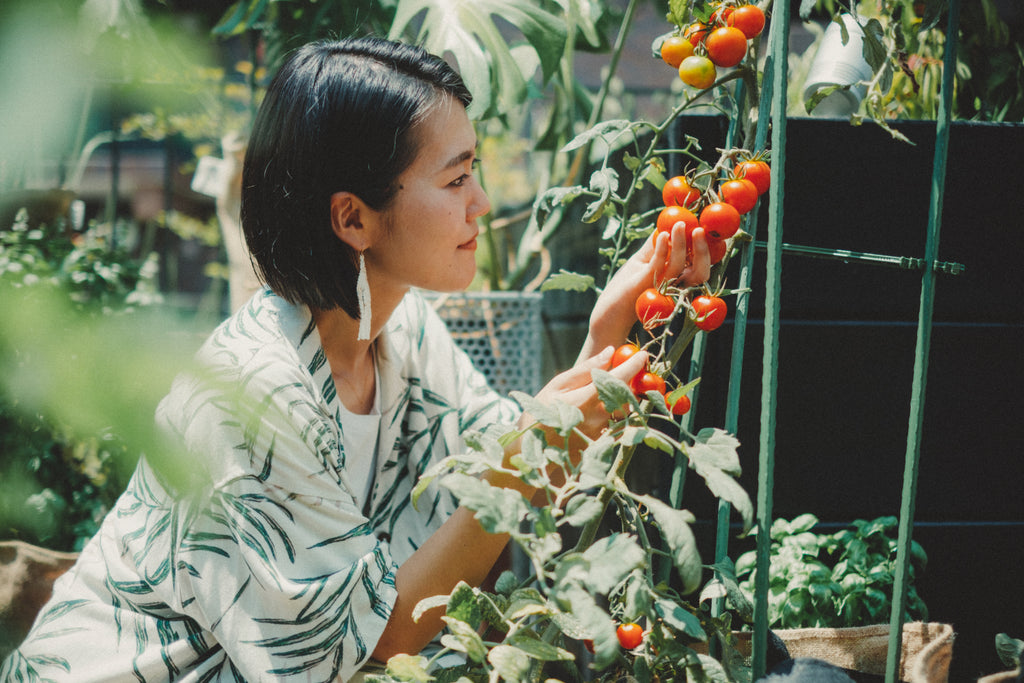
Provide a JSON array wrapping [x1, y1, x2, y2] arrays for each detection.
[[663, 117, 1024, 680]]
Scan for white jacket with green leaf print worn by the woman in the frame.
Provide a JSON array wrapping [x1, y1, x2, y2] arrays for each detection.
[[0, 291, 518, 683]]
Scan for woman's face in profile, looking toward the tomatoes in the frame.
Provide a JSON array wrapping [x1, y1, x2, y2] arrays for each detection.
[[366, 98, 490, 293]]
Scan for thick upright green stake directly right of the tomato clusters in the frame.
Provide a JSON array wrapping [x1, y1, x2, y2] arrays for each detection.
[[751, 2, 791, 680]]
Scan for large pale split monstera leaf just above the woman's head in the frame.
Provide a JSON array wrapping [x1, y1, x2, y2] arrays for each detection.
[[390, 0, 566, 119]]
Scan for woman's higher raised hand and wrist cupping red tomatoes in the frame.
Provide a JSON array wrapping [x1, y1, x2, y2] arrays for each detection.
[[580, 222, 711, 360]]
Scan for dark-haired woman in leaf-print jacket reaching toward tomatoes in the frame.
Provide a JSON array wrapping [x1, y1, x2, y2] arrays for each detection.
[[0, 39, 710, 683]]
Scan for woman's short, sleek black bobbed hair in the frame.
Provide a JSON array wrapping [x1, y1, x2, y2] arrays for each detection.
[[242, 37, 472, 318]]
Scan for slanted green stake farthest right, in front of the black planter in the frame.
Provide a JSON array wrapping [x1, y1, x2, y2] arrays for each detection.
[[886, 0, 961, 683]]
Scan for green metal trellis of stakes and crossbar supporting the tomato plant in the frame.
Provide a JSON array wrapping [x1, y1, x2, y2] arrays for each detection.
[[670, 0, 964, 683]]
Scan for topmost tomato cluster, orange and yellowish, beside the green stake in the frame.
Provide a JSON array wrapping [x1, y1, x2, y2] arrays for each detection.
[[660, 3, 765, 90]]
